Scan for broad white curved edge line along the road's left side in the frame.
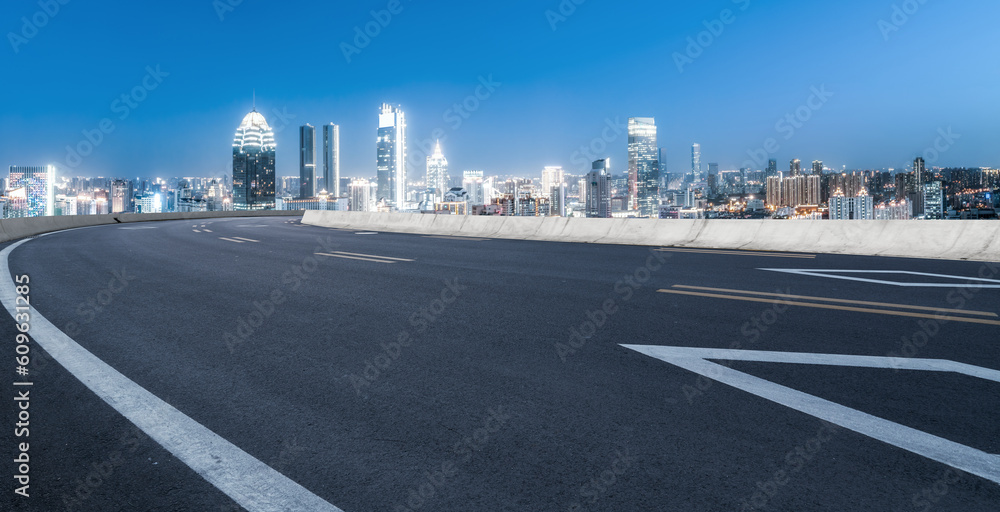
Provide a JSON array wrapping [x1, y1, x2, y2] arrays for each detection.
[[0, 240, 343, 512]]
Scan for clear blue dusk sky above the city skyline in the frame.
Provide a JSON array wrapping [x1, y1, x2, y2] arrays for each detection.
[[0, 0, 1000, 181]]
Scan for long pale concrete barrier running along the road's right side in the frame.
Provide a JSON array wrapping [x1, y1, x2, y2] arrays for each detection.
[[302, 211, 1000, 261]]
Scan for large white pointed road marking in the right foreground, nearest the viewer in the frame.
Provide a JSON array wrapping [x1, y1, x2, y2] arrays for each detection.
[[622, 345, 1000, 484]]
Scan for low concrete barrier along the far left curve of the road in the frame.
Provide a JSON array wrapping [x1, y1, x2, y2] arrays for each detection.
[[0, 211, 302, 242]]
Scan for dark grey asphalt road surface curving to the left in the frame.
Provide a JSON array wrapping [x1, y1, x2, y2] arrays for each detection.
[[0, 218, 1000, 512]]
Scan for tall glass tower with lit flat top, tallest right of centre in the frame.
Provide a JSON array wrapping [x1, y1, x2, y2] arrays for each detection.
[[628, 117, 660, 218]]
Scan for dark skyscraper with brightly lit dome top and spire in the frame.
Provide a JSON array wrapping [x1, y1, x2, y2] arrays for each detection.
[[233, 108, 275, 210]]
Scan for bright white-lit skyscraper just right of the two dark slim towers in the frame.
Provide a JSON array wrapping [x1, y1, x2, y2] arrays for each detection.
[[376, 103, 406, 210]]
